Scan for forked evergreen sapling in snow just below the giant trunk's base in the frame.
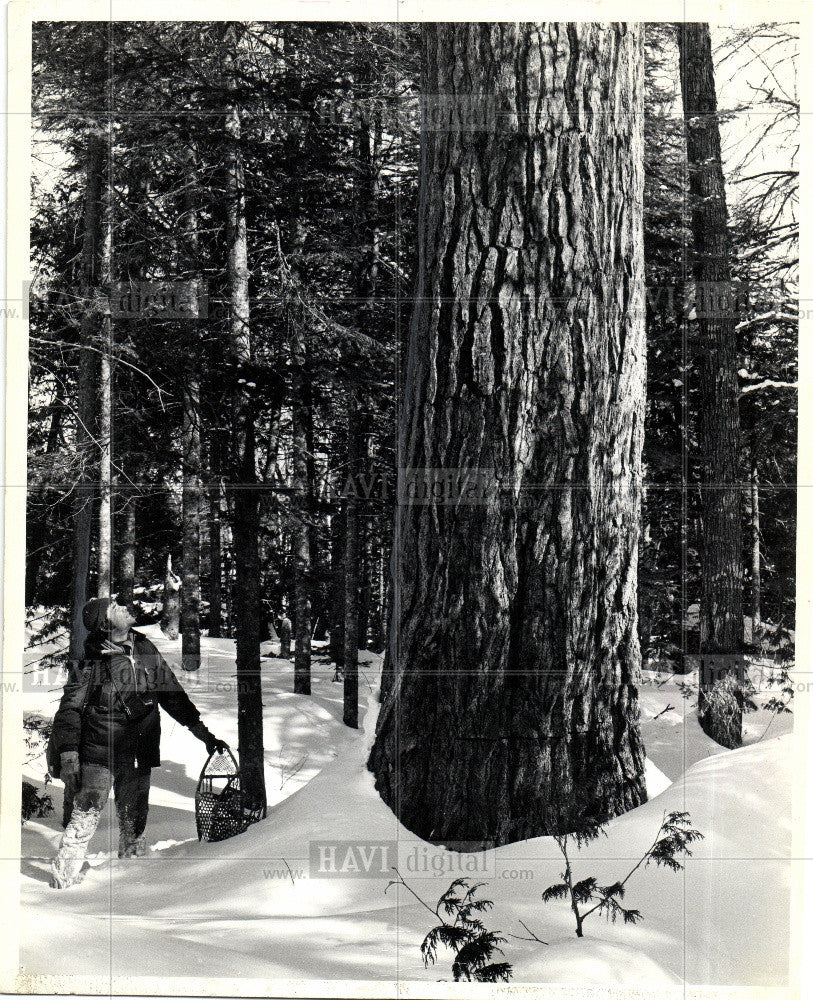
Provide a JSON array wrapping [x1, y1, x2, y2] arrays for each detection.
[[542, 812, 703, 937]]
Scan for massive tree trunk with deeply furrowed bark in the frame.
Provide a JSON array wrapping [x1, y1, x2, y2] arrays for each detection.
[[369, 23, 646, 844]]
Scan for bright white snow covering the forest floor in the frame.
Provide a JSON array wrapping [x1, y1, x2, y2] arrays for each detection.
[[20, 627, 794, 995]]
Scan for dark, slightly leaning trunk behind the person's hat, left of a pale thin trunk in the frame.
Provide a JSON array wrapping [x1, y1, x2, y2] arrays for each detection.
[[68, 132, 104, 661]]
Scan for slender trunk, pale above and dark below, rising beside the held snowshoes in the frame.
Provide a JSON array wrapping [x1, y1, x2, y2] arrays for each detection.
[[226, 95, 266, 815]]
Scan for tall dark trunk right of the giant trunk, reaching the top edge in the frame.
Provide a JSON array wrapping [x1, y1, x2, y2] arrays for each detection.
[[678, 23, 744, 747]]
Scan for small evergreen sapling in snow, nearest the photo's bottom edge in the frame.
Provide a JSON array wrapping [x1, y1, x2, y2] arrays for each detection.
[[385, 868, 512, 983]]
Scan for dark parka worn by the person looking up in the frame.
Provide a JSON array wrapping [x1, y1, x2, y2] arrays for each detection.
[[52, 632, 200, 777]]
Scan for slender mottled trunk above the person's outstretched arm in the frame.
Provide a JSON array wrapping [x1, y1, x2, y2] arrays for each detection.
[[181, 157, 201, 670]]
